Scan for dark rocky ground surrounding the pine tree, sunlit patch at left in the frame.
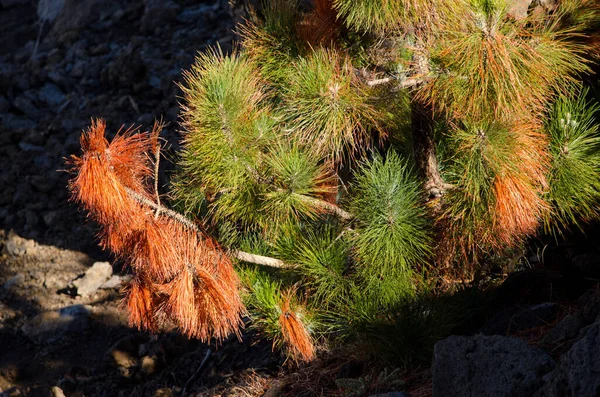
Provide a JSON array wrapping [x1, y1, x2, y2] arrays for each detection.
[[0, 0, 600, 397]]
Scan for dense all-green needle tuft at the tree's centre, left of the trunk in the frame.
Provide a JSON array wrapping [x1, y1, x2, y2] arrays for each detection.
[[350, 152, 431, 301]]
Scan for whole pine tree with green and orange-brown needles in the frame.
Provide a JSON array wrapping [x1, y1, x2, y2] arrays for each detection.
[[71, 0, 600, 363]]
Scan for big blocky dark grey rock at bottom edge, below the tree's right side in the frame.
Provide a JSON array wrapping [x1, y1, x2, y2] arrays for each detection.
[[432, 335, 556, 397]]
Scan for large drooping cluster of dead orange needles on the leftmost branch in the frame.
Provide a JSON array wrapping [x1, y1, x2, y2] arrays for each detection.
[[69, 120, 245, 341]]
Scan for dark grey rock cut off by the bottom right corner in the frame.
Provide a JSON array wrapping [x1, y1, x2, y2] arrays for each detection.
[[535, 322, 600, 397]]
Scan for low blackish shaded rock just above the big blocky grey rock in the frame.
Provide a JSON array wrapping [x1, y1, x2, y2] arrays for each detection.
[[481, 302, 558, 335]]
